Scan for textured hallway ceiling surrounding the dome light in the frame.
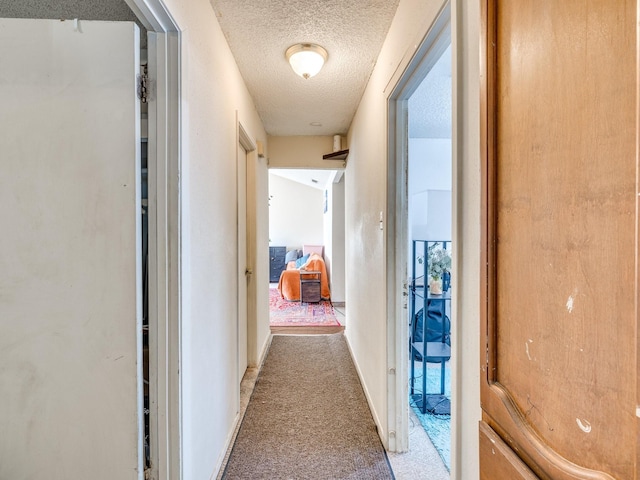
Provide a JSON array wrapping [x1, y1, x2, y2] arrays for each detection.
[[211, 0, 398, 136]]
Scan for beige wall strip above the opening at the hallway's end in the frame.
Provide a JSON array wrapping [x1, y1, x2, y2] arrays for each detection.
[[268, 135, 346, 170]]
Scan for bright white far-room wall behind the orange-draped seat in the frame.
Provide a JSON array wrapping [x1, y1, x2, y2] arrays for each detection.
[[265, 173, 324, 248]]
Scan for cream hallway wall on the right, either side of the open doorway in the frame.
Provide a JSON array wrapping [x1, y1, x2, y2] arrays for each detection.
[[346, 0, 480, 479]]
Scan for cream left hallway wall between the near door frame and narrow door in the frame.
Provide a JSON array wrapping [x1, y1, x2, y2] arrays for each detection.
[[165, 0, 268, 479]]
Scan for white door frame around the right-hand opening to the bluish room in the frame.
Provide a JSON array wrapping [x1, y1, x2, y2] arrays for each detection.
[[386, 0, 450, 452]]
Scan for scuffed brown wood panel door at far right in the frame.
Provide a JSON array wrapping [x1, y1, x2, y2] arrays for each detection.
[[479, 0, 638, 480]]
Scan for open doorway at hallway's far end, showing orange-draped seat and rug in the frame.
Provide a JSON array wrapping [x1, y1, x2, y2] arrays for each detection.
[[269, 168, 345, 333]]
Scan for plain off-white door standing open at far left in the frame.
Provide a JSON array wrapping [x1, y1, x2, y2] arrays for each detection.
[[0, 19, 142, 480]]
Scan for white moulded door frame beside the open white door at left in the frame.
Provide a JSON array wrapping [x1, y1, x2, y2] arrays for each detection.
[[125, 0, 182, 479]]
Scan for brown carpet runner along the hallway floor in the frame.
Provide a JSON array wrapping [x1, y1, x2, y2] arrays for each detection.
[[222, 333, 394, 480]]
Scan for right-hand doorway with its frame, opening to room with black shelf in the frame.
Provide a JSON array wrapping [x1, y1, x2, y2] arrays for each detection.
[[387, 3, 456, 479]]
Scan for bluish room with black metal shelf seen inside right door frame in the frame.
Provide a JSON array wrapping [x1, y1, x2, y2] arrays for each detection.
[[407, 42, 454, 470]]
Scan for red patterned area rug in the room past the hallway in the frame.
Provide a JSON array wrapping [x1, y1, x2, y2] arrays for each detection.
[[269, 288, 340, 327]]
